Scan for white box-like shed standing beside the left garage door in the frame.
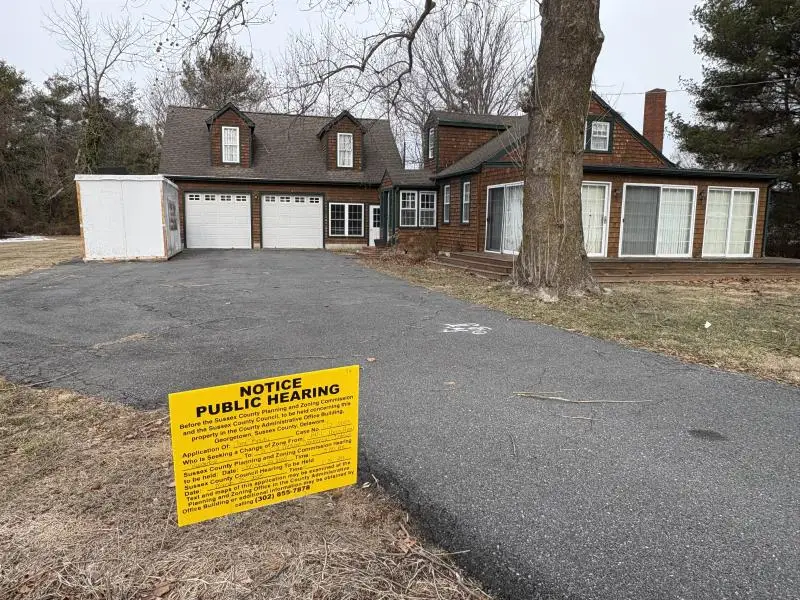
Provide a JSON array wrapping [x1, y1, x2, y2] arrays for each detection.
[[75, 175, 183, 261]]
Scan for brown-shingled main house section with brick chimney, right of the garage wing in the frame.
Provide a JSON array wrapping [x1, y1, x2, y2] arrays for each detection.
[[386, 90, 773, 262]]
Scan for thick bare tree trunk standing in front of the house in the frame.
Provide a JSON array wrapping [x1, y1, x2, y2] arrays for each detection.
[[513, 0, 603, 298]]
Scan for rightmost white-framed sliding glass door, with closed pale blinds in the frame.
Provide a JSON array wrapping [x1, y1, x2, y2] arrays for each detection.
[[703, 188, 758, 257]]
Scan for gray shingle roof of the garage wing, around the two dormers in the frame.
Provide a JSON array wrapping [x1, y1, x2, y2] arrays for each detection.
[[159, 106, 402, 185]]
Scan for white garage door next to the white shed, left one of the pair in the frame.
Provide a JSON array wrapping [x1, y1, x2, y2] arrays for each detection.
[[186, 193, 252, 248]]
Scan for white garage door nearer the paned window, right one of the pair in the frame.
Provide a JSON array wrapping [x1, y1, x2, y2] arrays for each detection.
[[261, 195, 322, 248]]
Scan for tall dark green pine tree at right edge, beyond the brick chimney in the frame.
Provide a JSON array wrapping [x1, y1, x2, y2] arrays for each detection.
[[670, 0, 800, 188]]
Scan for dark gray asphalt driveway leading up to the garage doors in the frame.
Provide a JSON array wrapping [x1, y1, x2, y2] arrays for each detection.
[[0, 251, 800, 600]]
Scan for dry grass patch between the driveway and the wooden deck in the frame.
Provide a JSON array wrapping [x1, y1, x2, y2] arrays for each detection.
[[366, 259, 800, 385]]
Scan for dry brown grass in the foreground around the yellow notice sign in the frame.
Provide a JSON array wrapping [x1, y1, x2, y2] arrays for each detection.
[[0, 379, 488, 600]]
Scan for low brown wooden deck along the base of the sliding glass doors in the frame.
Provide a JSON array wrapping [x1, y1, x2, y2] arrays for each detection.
[[435, 252, 800, 283]]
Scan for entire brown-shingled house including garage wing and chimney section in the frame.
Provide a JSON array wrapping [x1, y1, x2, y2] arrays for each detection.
[[160, 90, 772, 276]]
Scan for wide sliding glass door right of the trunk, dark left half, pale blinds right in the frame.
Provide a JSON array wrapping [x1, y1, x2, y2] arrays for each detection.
[[620, 185, 696, 258]]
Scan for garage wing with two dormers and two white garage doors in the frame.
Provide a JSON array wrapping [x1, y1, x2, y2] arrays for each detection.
[[160, 104, 432, 248]]
